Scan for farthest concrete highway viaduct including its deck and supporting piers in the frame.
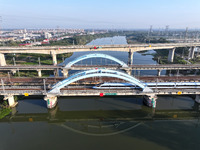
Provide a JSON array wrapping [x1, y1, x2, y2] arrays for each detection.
[[0, 43, 200, 66]]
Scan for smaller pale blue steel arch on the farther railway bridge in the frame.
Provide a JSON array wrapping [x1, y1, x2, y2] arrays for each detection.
[[64, 53, 128, 68]]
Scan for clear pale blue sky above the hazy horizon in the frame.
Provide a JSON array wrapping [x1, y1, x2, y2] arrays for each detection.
[[0, 0, 200, 29]]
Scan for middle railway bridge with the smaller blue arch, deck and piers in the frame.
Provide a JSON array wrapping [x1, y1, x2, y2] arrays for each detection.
[[0, 53, 200, 77]]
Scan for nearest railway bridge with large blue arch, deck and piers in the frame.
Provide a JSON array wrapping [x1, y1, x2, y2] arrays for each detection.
[[0, 69, 200, 108]]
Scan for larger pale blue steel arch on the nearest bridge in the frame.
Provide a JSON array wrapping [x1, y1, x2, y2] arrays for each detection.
[[48, 69, 152, 94]]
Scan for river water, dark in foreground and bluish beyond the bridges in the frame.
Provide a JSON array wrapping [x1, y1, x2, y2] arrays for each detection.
[[0, 37, 200, 150]]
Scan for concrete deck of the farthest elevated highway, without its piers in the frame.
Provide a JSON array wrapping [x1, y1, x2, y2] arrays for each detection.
[[0, 42, 200, 54]]
